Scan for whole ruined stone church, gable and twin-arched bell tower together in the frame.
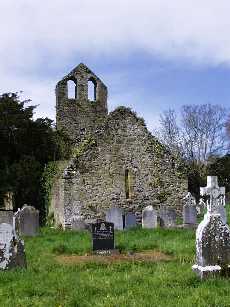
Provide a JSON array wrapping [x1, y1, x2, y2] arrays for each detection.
[[52, 64, 187, 228]]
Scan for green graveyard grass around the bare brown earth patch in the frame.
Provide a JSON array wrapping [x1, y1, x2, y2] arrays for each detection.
[[0, 212, 230, 307]]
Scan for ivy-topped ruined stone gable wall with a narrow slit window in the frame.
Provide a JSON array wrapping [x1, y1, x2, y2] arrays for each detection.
[[64, 108, 187, 223]]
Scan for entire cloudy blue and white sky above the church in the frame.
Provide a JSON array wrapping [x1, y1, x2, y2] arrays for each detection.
[[0, 0, 230, 130]]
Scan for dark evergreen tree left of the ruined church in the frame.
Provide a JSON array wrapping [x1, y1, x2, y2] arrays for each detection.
[[0, 93, 71, 220]]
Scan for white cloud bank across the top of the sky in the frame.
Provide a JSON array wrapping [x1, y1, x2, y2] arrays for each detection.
[[0, 0, 230, 127]]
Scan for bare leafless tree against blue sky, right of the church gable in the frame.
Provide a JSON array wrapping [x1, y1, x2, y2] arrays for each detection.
[[158, 104, 227, 165]]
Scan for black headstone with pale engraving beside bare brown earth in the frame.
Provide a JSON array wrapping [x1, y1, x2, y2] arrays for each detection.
[[92, 222, 114, 254]]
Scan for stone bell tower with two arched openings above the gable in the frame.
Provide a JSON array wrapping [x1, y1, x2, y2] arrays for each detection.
[[56, 63, 108, 144]]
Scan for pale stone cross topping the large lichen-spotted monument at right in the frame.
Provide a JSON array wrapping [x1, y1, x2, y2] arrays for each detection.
[[200, 176, 225, 214]]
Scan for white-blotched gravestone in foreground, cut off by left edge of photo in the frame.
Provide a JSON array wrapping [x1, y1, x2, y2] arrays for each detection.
[[0, 223, 26, 270]]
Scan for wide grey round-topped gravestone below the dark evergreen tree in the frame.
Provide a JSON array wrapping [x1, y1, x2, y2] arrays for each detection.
[[15, 205, 39, 236]]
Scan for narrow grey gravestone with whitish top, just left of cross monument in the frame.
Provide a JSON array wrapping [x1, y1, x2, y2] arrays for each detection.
[[183, 192, 197, 228]]
